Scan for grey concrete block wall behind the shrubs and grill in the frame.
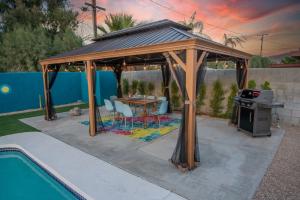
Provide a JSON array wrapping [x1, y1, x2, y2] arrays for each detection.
[[122, 68, 300, 126]]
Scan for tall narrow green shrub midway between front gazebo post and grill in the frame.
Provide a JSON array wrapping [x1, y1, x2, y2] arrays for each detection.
[[210, 80, 225, 117]]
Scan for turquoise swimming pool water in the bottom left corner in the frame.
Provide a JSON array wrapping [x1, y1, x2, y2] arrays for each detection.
[[0, 151, 78, 200]]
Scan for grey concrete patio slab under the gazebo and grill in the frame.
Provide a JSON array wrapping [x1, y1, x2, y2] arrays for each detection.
[[22, 110, 284, 200]]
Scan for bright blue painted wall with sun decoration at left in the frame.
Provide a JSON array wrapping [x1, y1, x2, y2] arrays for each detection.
[[0, 71, 116, 113]]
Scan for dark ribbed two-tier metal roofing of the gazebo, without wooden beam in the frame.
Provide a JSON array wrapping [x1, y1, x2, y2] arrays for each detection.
[[42, 19, 250, 64]]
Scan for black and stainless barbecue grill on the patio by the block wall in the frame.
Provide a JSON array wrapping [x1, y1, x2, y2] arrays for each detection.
[[234, 89, 283, 137]]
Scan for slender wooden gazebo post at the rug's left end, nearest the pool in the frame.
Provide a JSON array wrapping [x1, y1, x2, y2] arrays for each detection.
[[86, 60, 96, 136]]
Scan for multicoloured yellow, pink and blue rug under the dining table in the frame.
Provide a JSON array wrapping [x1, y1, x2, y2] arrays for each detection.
[[80, 116, 181, 142]]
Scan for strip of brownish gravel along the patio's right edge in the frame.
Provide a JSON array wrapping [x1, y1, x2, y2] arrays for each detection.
[[254, 127, 300, 200]]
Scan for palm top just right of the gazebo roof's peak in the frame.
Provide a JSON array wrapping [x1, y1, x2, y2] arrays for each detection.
[[180, 11, 211, 40]]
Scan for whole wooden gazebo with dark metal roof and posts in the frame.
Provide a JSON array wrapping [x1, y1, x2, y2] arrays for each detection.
[[40, 20, 251, 169]]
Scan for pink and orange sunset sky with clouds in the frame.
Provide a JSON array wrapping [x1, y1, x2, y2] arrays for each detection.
[[70, 0, 300, 55]]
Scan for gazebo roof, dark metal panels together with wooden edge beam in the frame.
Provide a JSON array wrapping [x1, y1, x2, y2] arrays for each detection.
[[41, 19, 251, 64]]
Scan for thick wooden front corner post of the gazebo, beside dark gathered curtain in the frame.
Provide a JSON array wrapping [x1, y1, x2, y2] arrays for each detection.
[[186, 48, 197, 169]]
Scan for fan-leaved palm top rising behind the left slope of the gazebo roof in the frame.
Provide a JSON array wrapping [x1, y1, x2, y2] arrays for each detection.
[[98, 13, 136, 34]]
